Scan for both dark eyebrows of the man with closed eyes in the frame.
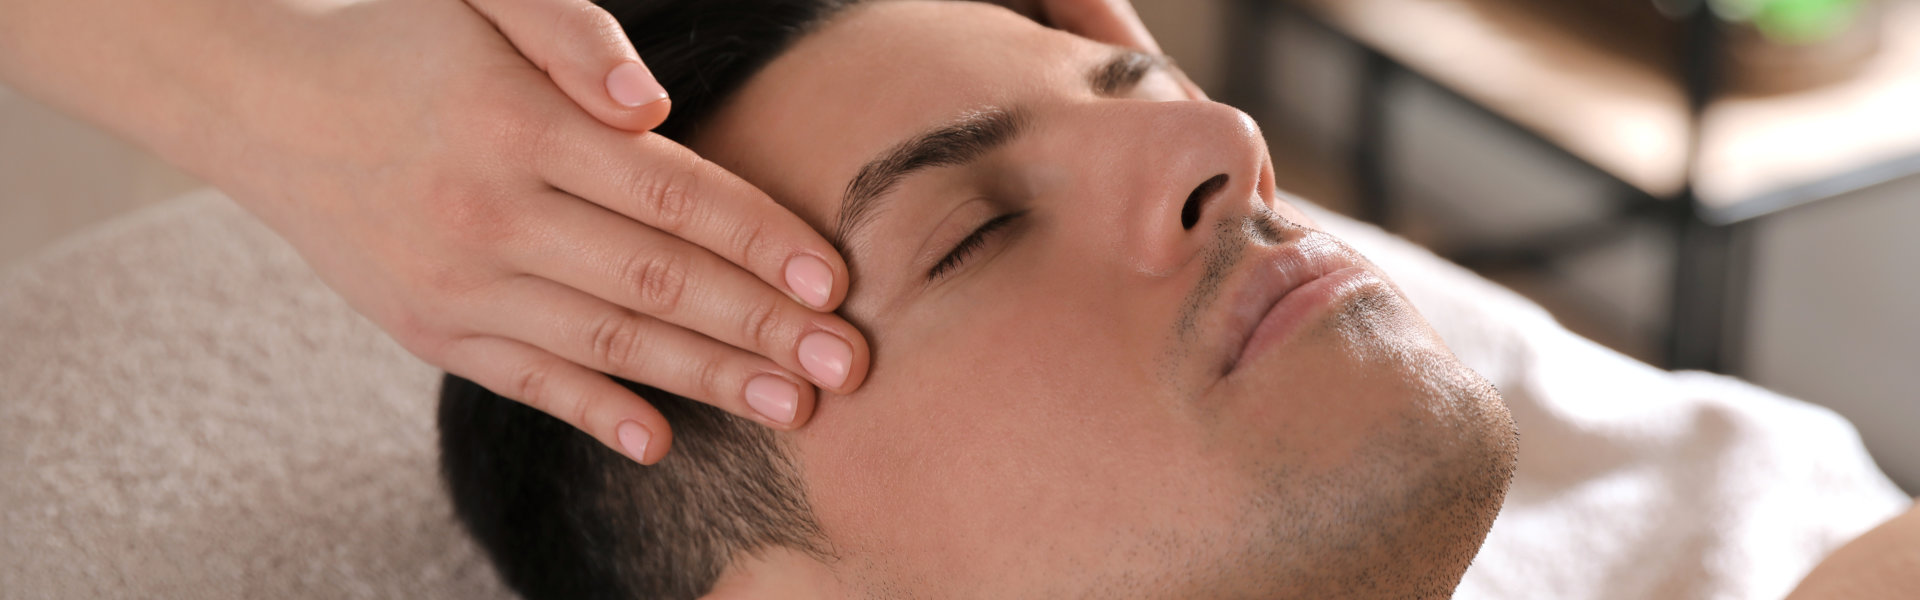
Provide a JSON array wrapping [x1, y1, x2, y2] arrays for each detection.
[[828, 48, 1169, 254]]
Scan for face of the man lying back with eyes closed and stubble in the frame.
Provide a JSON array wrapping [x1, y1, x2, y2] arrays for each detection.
[[695, 2, 1515, 598]]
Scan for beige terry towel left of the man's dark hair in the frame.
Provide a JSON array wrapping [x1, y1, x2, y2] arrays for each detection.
[[0, 192, 507, 600]]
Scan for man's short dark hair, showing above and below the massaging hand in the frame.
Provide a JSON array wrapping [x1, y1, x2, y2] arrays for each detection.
[[440, 0, 852, 600]]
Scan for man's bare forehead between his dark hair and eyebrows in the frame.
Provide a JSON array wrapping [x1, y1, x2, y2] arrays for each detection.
[[693, 0, 1104, 231]]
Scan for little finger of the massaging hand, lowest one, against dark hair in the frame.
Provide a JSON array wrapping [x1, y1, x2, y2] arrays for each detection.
[[445, 337, 674, 465]]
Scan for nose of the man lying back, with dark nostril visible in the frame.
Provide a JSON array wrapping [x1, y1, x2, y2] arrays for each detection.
[[1089, 102, 1273, 277]]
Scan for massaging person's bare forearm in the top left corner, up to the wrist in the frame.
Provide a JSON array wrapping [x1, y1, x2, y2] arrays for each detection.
[[0, 0, 316, 177]]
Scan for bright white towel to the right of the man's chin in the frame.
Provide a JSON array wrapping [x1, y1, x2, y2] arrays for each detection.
[[1313, 203, 1910, 600]]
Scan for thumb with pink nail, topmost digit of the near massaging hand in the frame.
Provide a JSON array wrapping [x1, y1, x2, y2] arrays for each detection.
[[467, 0, 670, 131]]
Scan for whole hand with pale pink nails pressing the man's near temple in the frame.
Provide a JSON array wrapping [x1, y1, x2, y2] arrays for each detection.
[[207, 0, 868, 463]]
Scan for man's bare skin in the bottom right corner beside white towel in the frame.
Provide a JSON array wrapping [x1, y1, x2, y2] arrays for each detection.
[[1788, 504, 1920, 600]]
